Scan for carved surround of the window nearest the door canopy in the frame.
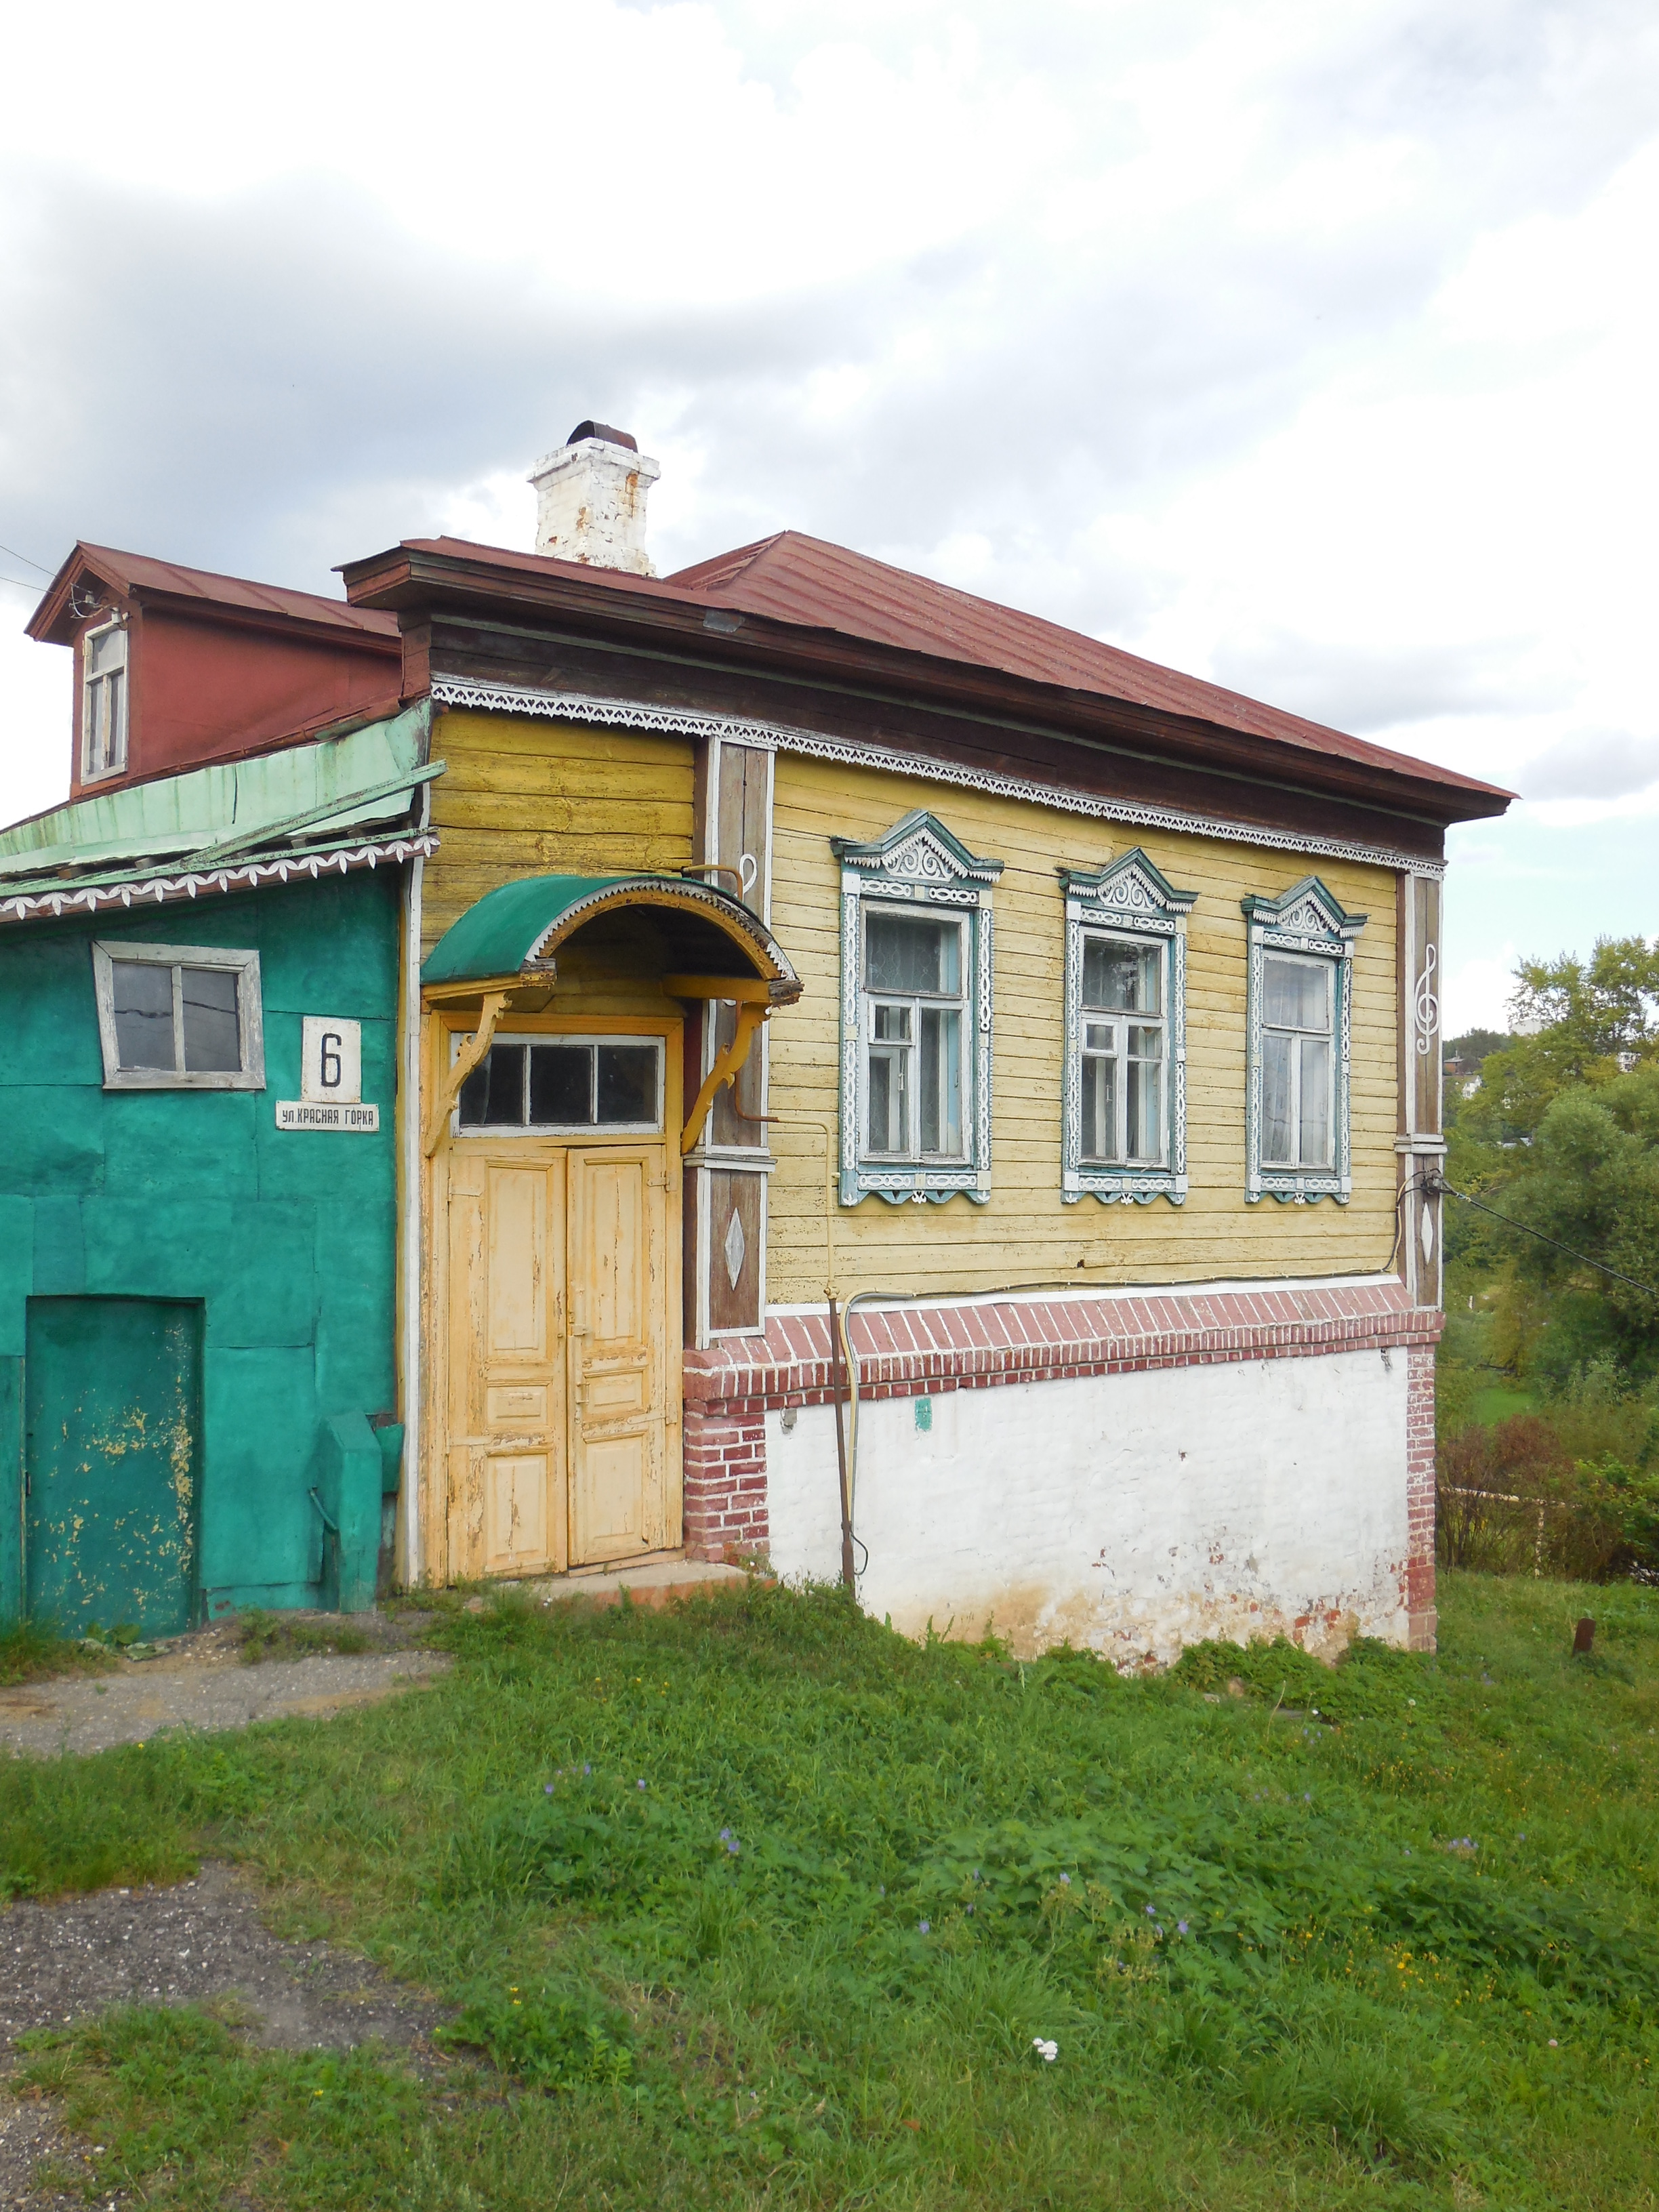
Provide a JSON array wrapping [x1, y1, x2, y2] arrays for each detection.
[[830, 810, 1002, 1206]]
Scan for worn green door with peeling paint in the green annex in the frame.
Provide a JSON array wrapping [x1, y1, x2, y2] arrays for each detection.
[[24, 1298, 201, 1637]]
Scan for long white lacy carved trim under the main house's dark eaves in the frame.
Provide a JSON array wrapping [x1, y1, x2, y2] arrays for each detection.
[[431, 677, 1447, 880]]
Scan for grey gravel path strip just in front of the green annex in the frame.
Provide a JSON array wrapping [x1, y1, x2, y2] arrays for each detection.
[[0, 1639, 449, 1759]]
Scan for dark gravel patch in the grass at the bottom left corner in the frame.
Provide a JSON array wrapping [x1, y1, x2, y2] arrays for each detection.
[[0, 1858, 462, 2212]]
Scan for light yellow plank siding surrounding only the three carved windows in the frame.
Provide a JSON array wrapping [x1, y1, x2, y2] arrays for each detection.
[[768, 752, 1398, 1305]]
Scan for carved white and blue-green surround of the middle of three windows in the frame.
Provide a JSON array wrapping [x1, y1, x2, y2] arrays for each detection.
[[1059, 845, 1199, 1206]]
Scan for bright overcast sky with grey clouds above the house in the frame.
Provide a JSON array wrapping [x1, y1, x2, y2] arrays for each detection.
[[0, 0, 1659, 1029]]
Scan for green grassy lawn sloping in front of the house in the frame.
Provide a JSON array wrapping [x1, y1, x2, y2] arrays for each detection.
[[0, 1577, 1659, 2212]]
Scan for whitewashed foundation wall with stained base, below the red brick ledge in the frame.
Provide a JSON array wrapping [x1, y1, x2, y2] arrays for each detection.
[[765, 1351, 1409, 1668]]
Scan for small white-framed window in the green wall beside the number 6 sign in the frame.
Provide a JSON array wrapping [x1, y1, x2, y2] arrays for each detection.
[[93, 942, 266, 1090]]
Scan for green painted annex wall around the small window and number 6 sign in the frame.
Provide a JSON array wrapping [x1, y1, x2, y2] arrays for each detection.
[[0, 867, 403, 1619]]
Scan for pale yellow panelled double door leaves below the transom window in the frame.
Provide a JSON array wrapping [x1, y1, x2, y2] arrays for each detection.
[[443, 1137, 681, 1579]]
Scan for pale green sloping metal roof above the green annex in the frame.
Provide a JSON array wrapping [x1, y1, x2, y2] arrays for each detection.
[[0, 699, 443, 894]]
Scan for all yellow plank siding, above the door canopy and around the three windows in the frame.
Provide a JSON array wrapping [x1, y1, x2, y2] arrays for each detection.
[[422, 710, 1398, 1305]]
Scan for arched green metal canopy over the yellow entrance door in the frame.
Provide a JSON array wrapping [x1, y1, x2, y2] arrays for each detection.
[[420, 876, 801, 998]]
